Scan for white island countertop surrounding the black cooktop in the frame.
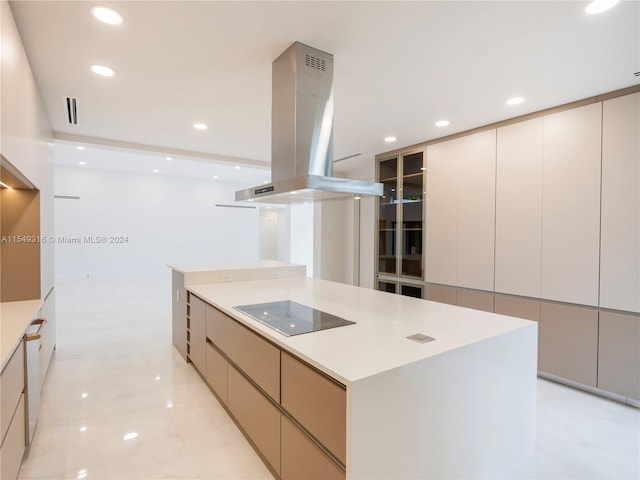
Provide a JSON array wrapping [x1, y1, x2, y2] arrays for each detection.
[[186, 277, 537, 385]]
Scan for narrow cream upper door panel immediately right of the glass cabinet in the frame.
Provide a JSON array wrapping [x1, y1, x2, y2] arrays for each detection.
[[425, 140, 458, 285]]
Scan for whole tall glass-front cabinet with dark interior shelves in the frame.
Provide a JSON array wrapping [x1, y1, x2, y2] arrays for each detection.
[[376, 150, 425, 297]]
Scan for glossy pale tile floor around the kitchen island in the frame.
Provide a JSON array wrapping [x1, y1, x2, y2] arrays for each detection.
[[20, 271, 640, 480]]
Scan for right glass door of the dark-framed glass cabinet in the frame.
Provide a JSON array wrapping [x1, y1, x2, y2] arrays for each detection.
[[400, 152, 424, 279]]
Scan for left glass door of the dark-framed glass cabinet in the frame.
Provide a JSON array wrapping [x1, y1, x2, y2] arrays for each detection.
[[378, 158, 398, 275]]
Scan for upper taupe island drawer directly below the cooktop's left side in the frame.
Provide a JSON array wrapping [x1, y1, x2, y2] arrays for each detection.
[[225, 320, 280, 402]]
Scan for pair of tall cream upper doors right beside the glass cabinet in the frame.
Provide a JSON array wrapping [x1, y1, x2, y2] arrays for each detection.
[[425, 130, 496, 290]]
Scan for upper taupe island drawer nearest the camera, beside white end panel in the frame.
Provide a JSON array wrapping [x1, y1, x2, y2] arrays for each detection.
[[281, 352, 347, 464]]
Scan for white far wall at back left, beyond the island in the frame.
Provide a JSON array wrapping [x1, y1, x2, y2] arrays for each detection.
[[55, 166, 260, 277]]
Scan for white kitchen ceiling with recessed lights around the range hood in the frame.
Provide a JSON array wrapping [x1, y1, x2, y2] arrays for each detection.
[[11, 0, 640, 172]]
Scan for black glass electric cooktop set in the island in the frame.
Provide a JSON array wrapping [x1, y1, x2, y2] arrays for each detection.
[[233, 300, 356, 337]]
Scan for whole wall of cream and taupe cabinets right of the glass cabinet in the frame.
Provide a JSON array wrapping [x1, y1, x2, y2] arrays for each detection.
[[384, 87, 640, 404]]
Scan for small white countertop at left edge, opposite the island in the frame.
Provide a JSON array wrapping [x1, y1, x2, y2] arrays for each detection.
[[0, 299, 42, 368]]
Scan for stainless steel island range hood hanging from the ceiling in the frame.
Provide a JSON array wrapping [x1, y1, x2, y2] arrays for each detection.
[[236, 42, 382, 204]]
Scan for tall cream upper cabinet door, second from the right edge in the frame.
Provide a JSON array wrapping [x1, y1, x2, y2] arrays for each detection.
[[541, 103, 602, 306]]
